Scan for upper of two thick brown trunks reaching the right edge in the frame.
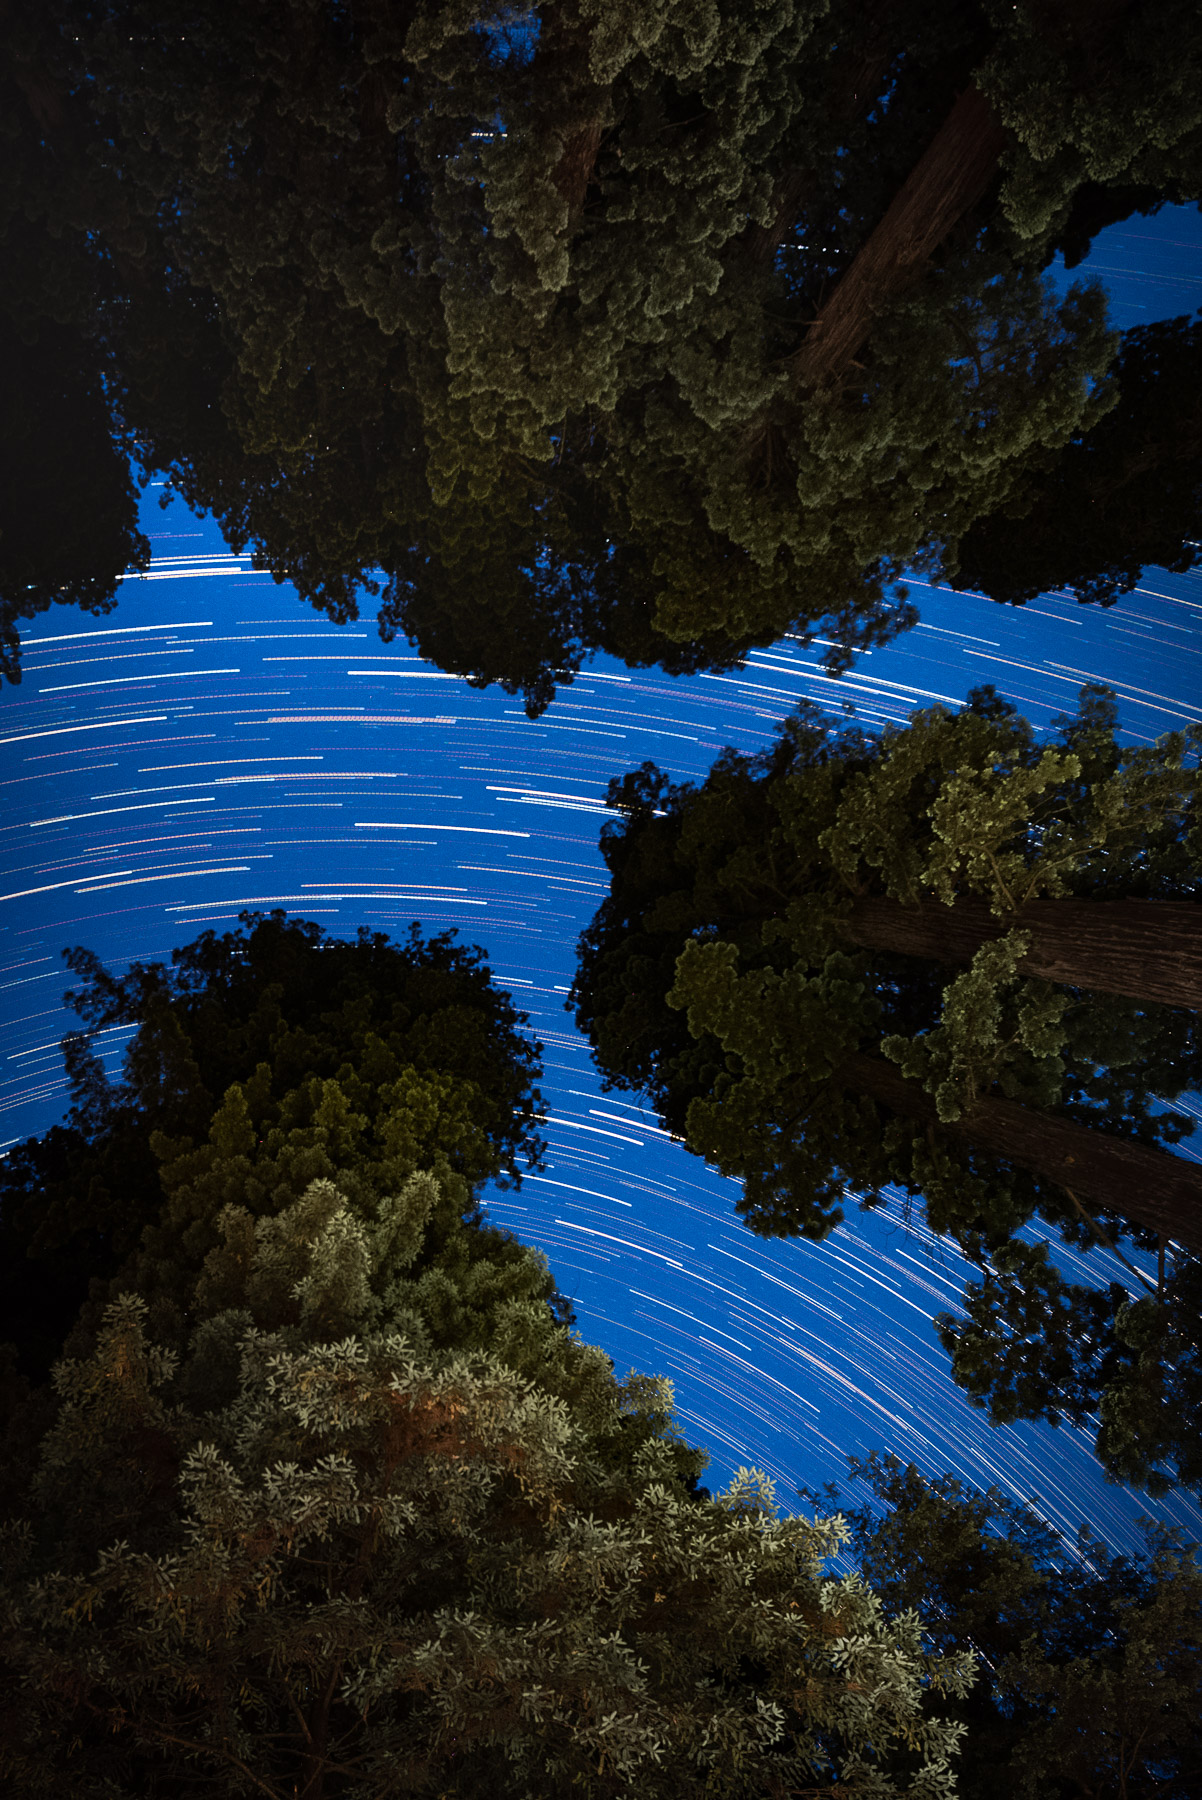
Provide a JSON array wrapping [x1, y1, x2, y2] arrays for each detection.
[[842, 895, 1202, 1012]]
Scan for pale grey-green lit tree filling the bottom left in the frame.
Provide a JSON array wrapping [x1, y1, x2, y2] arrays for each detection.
[[0, 1123, 972, 1800]]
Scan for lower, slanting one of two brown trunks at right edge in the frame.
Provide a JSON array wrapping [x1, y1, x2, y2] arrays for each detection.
[[833, 1055, 1202, 1251]]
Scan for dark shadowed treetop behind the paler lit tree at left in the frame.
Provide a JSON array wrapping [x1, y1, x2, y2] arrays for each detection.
[[0, 913, 542, 1377]]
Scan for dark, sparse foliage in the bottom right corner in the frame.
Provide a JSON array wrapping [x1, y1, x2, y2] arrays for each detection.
[[803, 1456, 1202, 1800]]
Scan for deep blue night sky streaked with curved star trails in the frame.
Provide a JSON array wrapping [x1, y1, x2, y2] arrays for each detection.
[[0, 209, 1202, 1546]]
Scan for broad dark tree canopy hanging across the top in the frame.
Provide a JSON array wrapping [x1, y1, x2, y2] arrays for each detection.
[[9, 0, 1202, 711]]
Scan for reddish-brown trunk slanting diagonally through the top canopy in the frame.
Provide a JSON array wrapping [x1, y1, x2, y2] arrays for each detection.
[[792, 86, 1006, 392]]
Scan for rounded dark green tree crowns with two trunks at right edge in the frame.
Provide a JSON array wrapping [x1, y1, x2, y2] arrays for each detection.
[[572, 688, 1202, 1481]]
